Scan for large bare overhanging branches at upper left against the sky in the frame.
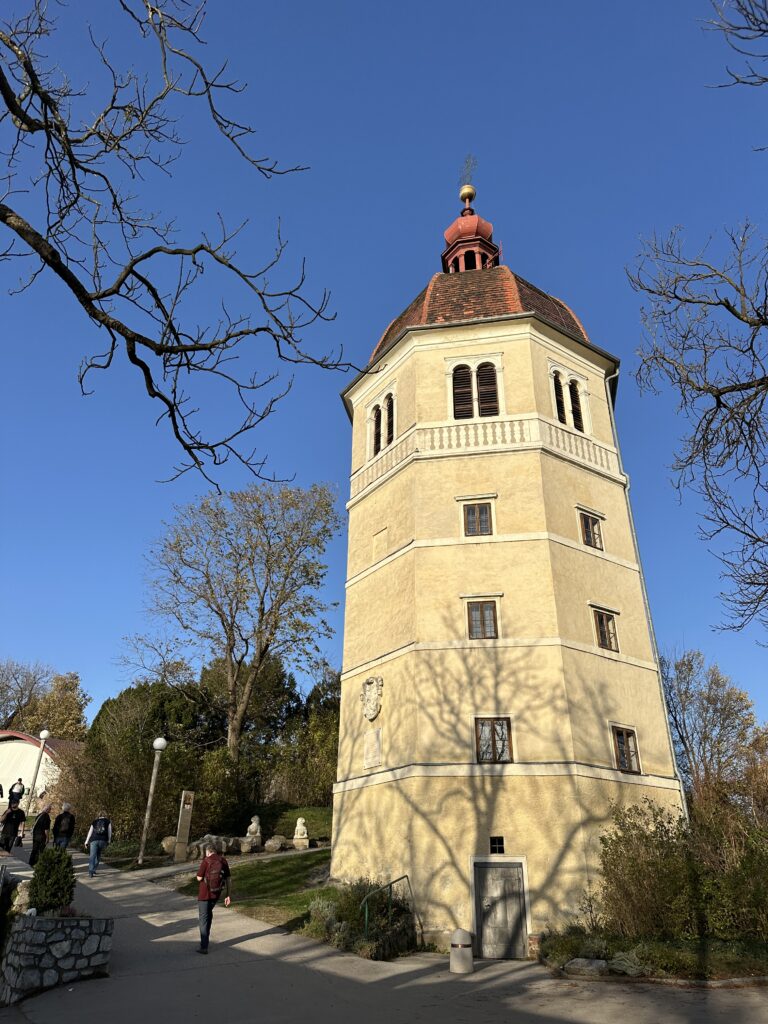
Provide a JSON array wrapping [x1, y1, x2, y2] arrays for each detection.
[[0, 0, 343, 478]]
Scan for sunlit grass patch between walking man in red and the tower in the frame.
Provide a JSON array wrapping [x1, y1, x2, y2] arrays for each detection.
[[179, 843, 331, 931]]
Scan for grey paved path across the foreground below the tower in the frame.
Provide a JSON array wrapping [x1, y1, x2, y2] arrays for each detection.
[[0, 855, 768, 1024]]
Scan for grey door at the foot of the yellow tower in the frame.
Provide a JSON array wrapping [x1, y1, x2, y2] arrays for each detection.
[[475, 863, 528, 959]]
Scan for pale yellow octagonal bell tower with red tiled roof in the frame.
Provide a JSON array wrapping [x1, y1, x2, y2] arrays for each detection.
[[332, 185, 682, 957]]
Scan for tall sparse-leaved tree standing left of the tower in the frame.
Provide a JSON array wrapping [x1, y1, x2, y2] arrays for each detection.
[[133, 483, 341, 760]]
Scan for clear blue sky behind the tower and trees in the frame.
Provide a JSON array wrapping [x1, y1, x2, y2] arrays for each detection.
[[0, 0, 768, 718]]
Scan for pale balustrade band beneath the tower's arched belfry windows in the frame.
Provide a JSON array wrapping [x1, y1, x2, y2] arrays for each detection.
[[350, 417, 620, 498]]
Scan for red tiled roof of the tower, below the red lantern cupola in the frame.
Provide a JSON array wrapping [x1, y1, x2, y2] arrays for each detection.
[[371, 266, 590, 362]]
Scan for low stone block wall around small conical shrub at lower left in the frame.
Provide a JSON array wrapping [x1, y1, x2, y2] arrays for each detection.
[[0, 915, 115, 1007]]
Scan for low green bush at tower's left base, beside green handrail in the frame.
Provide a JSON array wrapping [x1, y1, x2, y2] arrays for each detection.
[[304, 879, 417, 959]]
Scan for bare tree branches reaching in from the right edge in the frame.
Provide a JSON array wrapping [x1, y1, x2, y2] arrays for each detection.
[[630, 0, 768, 629]]
